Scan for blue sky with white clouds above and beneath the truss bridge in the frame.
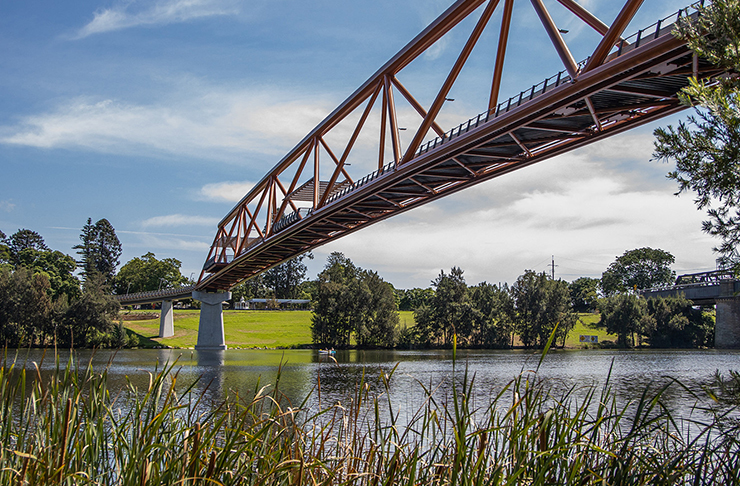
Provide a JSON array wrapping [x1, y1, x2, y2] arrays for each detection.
[[0, 0, 716, 288]]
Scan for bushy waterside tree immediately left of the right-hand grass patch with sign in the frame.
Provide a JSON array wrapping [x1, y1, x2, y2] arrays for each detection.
[[511, 270, 578, 347]]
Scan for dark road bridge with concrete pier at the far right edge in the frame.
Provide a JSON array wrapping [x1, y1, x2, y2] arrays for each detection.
[[640, 271, 740, 348]]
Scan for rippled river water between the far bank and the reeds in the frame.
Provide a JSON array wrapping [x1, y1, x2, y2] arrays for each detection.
[[7, 349, 740, 420]]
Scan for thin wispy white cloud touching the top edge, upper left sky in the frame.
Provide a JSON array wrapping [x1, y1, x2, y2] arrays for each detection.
[[74, 0, 237, 39]]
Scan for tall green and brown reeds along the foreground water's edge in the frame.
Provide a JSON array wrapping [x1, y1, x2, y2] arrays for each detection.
[[0, 352, 740, 486]]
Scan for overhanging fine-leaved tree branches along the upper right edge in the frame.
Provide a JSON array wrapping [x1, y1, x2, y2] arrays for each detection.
[[653, 0, 740, 269]]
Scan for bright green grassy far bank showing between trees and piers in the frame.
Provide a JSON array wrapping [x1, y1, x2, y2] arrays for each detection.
[[121, 309, 616, 349]]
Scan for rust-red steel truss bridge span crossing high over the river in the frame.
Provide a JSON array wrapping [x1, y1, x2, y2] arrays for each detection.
[[196, 0, 724, 292]]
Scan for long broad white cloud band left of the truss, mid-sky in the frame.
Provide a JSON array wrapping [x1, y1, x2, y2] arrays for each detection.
[[0, 87, 331, 162]]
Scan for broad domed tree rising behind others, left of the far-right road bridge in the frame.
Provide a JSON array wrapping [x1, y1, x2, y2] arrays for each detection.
[[601, 247, 676, 297]]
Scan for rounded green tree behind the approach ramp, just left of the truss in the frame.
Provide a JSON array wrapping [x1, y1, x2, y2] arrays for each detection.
[[115, 252, 188, 294]]
